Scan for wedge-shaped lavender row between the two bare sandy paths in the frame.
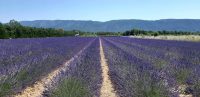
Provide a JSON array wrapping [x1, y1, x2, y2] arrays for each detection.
[[49, 38, 102, 97]]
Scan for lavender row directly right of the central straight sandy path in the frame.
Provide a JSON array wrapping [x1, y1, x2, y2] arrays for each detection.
[[103, 40, 173, 97]]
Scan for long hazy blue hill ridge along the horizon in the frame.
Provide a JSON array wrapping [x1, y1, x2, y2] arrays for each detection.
[[20, 19, 200, 32]]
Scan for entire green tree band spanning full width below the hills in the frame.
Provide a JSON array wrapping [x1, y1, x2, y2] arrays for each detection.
[[0, 20, 200, 39]]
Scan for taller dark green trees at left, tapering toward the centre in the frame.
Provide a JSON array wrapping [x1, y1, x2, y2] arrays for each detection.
[[0, 20, 83, 39]]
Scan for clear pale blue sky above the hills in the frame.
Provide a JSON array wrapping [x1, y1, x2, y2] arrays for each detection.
[[0, 0, 200, 22]]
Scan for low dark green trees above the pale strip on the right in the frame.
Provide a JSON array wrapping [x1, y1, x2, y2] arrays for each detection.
[[122, 29, 200, 36]]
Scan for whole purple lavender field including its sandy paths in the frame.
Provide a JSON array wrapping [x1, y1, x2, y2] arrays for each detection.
[[0, 37, 200, 97]]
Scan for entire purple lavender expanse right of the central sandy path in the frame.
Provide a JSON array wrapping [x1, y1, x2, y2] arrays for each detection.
[[101, 37, 200, 97]]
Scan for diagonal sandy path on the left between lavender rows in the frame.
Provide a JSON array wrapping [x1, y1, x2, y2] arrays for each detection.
[[14, 40, 94, 97]]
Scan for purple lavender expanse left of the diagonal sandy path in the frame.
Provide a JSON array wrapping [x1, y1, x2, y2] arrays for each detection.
[[0, 37, 93, 96]]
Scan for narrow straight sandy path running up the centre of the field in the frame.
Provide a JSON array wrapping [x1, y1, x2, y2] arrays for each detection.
[[99, 39, 118, 97]]
